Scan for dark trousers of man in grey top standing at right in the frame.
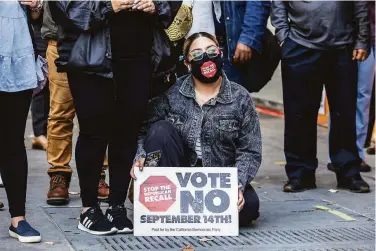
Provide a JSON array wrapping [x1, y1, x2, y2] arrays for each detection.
[[282, 39, 360, 178]]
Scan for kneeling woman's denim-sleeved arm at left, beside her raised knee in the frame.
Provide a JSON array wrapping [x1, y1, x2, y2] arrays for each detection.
[[134, 94, 170, 161]]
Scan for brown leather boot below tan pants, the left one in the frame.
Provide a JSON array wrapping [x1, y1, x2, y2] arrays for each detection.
[[47, 174, 69, 206]]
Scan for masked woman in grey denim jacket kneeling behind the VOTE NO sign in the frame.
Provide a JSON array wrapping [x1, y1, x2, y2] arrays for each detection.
[[131, 32, 261, 225]]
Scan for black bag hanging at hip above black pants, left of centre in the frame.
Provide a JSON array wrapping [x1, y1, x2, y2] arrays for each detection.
[[67, 27, 111, 73]]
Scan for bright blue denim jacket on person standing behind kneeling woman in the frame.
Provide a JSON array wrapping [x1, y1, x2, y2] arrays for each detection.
[[223, 1, 270, 62]]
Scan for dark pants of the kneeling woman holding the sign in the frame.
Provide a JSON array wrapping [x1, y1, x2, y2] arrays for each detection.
[[144, 121, 260, 225]]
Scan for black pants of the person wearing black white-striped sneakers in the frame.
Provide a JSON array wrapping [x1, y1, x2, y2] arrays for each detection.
[[68, 58, 151, 207]]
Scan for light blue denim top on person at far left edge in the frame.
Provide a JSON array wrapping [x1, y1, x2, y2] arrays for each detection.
[[0, 1, 37, 92]]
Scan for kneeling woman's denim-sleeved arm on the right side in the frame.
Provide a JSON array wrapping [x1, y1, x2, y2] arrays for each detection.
[[235, 96, 262, 192]]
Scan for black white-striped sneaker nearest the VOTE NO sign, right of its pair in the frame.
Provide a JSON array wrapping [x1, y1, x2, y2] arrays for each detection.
[[106, 205, 133, 234]]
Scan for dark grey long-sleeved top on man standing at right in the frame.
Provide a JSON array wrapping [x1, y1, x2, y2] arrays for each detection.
[[271, 1, 370, 50]]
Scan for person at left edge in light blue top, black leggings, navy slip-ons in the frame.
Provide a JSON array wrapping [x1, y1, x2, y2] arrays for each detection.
[[0, 1, 41, 243]]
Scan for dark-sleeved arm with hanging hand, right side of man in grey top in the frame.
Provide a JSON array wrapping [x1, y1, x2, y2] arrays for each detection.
[[353, 1, 371, 61]]
